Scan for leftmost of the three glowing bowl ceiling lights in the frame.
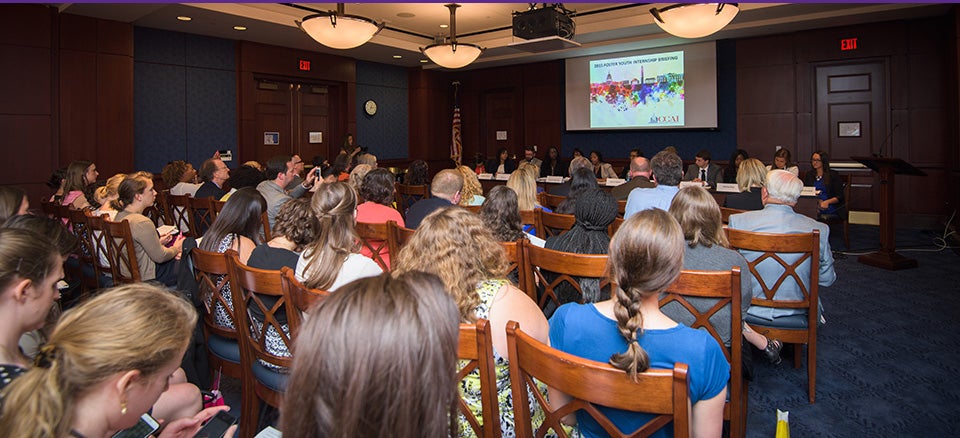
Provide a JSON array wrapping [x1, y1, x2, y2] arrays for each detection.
[[296, 3, 383, 49]]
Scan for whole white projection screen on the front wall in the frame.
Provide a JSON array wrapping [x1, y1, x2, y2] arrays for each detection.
[[564, 41, 717, 131]]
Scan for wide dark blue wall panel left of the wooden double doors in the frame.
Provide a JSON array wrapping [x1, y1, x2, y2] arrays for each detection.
[[133, 27, 237, 172]]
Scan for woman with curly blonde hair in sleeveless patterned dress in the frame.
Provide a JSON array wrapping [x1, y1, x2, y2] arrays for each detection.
[[393, 207, 548, 436]]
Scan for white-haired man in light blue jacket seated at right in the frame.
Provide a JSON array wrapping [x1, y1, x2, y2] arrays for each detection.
[[729, 169, 837, 323]]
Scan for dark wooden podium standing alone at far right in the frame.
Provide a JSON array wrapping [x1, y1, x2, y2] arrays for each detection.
[[850, 157, 927, 271]]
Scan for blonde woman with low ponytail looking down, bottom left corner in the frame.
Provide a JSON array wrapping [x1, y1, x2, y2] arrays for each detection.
[[0, 283, 232, 437]]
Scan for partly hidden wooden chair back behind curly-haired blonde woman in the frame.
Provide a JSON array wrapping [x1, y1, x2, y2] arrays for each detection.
[[457, 319, 501, 438]]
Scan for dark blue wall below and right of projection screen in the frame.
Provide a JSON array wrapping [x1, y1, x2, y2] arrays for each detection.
[[560, 40, 737, 161]]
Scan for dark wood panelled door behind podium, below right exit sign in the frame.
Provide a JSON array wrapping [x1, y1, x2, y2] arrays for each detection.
[[812, 60, 892, 211]]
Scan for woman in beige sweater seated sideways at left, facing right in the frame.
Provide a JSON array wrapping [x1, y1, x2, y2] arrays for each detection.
[[115, 173, 183, 286]]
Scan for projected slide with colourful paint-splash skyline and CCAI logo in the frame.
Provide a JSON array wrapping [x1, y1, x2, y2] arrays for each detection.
[[590, 51, 684, 128]]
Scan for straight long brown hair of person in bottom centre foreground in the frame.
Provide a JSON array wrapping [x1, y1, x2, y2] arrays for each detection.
[[280, 272, 464, 438]]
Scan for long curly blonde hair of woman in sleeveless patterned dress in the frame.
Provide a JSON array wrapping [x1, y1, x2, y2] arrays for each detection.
[[393, 207, 507, 323]]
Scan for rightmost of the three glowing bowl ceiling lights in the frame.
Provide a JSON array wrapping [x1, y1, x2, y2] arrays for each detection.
[[650, 3, 740, 38]]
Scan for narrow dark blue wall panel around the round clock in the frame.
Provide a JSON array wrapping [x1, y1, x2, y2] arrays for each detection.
[[354, 61, 410, 160]]
